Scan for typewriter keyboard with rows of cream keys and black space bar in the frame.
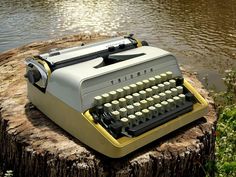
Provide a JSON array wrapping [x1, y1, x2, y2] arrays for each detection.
[[89, 71, 196, 138]]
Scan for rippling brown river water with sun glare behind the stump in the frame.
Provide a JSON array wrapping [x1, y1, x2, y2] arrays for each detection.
[[0, 0, 236, 89]]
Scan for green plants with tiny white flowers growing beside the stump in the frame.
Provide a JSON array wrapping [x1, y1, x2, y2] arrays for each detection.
[[0, 35, 236, 177]]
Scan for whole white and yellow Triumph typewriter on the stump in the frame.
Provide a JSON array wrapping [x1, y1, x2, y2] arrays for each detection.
[[25, 35, 208, 158]]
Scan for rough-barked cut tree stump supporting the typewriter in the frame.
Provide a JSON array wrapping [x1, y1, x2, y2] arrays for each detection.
[[0, 34, 217, 177]]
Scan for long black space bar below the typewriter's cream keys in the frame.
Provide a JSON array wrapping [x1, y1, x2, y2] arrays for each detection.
[[127, 101, 193, 136]]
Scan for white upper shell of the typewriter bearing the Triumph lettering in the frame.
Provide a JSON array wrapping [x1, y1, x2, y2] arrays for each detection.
[[46, 46, 181, 112]]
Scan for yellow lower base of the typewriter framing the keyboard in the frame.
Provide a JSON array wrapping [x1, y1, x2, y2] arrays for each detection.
[[28, 81, 208, 158]]
